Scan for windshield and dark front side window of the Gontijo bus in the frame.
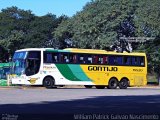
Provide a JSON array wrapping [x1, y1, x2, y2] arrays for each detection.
[[12, 51, 40, 76]]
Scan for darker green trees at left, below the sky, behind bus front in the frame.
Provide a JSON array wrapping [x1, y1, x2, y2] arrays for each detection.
[[0, 7, 68, 61]]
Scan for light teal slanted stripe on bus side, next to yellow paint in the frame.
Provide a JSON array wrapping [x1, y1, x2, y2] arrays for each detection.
[[68, 64, 92, 81]]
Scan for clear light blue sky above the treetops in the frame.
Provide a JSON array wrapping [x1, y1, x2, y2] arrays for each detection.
[[0, 0, 91, 17]]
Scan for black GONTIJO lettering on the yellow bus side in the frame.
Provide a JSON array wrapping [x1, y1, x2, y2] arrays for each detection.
[[88, 66, 118, 71]]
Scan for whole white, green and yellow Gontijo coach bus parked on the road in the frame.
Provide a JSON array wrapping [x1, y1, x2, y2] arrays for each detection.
[[11, 48, 147, 89]]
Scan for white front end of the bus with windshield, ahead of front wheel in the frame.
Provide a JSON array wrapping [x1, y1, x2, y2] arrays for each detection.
[[11, 49, 41, 85]]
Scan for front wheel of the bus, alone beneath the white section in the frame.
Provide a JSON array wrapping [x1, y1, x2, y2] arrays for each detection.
[[43, 77, 54, 88]]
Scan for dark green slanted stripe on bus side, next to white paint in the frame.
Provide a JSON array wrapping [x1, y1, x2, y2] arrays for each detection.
[[56, 64, 81, 81]]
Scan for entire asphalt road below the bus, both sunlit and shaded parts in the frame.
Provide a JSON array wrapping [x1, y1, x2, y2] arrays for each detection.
[[0, 87, 160, 120]]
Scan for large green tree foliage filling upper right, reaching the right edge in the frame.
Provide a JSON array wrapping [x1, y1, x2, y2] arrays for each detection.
[[54, 0, 160, 71]]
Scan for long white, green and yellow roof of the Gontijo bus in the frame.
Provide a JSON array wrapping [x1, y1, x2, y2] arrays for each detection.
[[16, 48, 146, 56]]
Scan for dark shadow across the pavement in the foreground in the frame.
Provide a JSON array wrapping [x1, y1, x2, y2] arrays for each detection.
[[0, 95, 160, 120]]
